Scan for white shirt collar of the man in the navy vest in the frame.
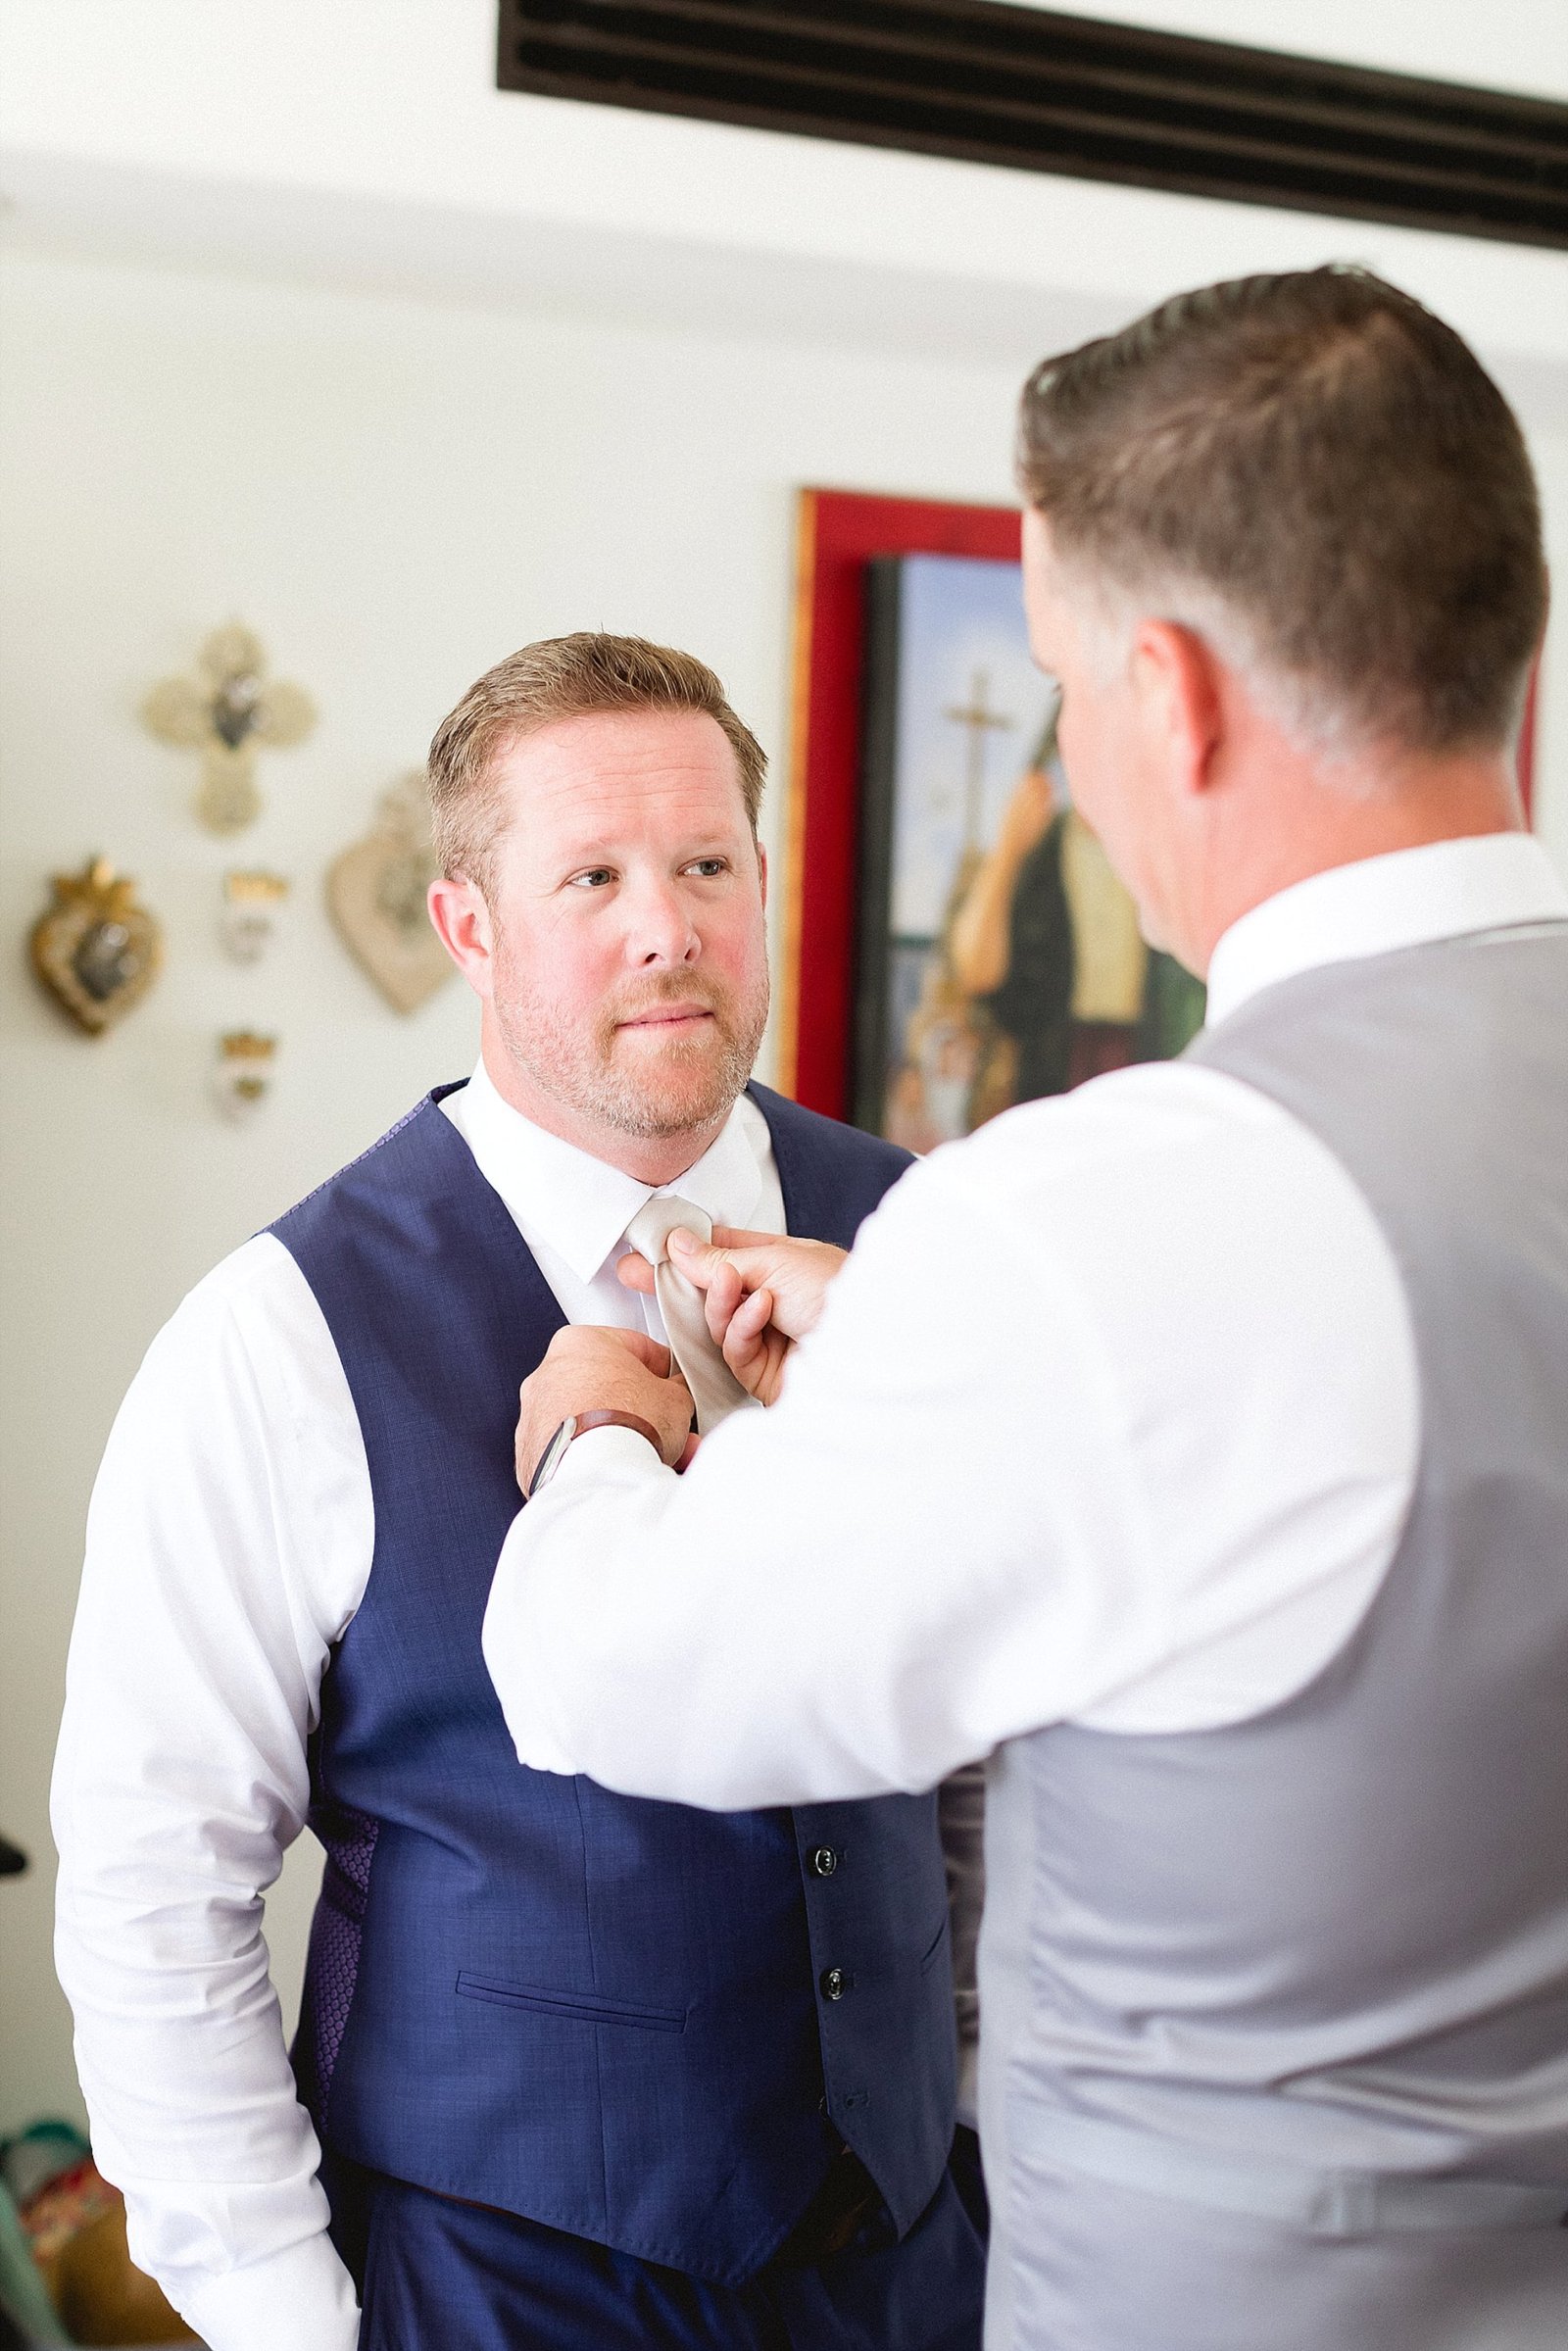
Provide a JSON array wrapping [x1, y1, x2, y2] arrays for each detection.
[[451, 1062, 764, 1281]]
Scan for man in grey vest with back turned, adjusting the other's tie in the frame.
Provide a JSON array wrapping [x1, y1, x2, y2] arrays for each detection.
[[487, 268, 1568, 2351]]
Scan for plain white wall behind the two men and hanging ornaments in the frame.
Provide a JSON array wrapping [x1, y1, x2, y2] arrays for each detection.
[[0, 0, 1568, 2130]]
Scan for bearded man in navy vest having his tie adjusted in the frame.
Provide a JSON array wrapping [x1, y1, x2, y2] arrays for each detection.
[[54, 635, 983, 2351]]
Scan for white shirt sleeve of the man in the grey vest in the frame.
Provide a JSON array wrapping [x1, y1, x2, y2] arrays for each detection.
[[484, 1065, 1420, 1808]]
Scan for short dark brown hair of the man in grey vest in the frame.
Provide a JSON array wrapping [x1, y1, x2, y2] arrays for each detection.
[[1018, 266, 1546, 753]]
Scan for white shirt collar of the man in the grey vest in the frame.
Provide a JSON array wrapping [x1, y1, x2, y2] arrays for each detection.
[[1208, 832, 1568, 1027]]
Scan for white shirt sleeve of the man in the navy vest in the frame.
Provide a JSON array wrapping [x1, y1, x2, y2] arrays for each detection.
[[52, 1237, 371, 2351]]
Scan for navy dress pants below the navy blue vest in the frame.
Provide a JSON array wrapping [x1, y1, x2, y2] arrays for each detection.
[[360, 2175, 985, 2351]]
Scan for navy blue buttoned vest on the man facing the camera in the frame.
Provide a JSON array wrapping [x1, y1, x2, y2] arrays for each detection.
[[272, 1089, 955, 2282]]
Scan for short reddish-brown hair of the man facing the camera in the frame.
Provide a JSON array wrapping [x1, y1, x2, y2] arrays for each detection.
[[430, 630, 768, 889]]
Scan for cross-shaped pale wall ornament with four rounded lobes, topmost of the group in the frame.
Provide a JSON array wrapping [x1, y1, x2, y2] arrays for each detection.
[[141, 620, 315, 832]]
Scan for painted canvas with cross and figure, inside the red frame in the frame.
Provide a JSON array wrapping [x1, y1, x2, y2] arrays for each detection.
[[856, 555, 1203, 1152]]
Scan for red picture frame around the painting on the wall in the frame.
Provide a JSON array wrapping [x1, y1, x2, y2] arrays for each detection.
[[778, 489, 1535, 1119]]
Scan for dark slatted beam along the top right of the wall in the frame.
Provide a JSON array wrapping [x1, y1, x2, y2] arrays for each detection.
[[499, 0, 1568, 247]]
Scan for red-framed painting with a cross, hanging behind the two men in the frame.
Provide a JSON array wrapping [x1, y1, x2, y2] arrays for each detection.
[[778, 489, 1535, 1150]]
